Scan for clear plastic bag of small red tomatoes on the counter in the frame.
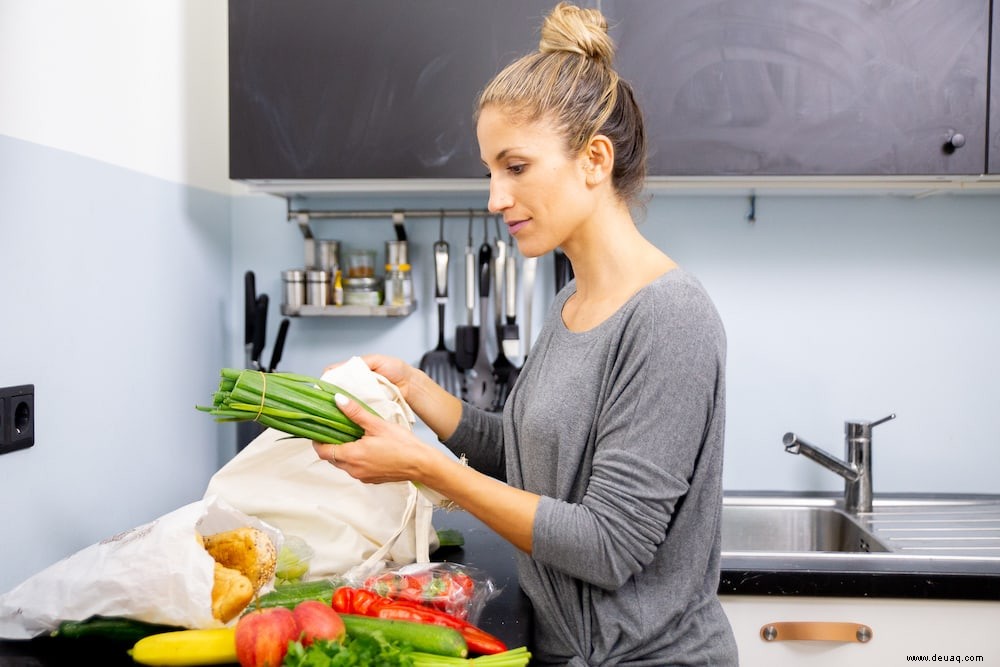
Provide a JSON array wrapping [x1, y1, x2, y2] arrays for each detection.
[[361, 562, 500, 623]]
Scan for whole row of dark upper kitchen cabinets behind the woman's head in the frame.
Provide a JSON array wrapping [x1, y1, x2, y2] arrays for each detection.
[[229, 0, 1000, 187]]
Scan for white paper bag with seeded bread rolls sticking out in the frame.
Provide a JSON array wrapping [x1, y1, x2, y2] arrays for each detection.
[[0, 497, 283, 639]]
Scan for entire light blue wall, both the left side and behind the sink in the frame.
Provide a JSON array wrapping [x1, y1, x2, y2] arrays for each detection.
[[0, 132, 1000, 591]]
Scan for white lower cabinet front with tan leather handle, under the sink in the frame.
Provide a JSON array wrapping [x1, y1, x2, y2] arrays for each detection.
[[720, 595, 1000, 667]]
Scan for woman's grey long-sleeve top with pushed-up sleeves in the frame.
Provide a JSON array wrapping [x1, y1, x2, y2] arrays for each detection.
[[445, 269, 737, 667]]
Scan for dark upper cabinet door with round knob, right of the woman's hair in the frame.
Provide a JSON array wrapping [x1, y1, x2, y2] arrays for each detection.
[[602, 0, 1000, 176]]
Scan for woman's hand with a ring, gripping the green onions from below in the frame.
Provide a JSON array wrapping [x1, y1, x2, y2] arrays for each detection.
[[313, 392, 444, 484]]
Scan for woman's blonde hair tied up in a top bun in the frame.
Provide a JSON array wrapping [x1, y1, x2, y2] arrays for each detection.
[[476, 2, 646, 203]]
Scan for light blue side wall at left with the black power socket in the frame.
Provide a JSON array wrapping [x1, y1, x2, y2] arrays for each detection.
[[0, 136, 231, 591]]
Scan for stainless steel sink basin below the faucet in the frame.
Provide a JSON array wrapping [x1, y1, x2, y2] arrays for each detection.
[[722, 503, 888, 553]]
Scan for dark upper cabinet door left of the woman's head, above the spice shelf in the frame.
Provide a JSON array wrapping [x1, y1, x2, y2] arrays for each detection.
[[229, 0, 554, 180]]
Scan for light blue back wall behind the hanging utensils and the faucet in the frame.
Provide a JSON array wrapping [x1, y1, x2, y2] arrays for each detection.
[[232, 190, 1000, 493]]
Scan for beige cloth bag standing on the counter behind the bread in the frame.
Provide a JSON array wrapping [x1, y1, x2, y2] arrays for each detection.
[[205, 357, 446, 580]]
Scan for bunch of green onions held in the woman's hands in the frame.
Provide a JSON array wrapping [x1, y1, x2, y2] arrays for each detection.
[[195, 368, 378, 445]]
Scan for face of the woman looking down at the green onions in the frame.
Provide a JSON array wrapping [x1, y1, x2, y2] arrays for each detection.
[[476, 106, 593, 257]]
